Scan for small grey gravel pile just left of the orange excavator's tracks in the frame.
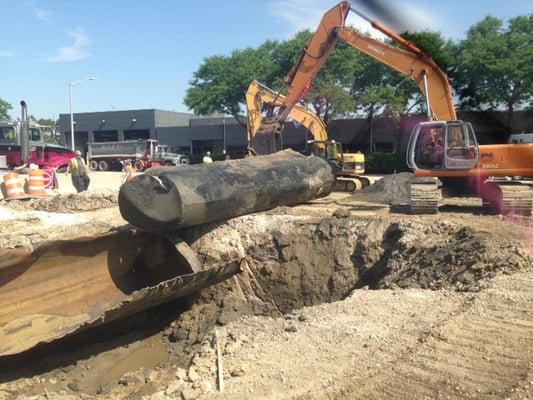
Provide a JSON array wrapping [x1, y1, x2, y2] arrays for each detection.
[[363, 172, 415, 205]]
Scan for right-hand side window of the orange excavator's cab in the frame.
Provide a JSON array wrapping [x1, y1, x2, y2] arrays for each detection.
[[445, 121, 479, 169]]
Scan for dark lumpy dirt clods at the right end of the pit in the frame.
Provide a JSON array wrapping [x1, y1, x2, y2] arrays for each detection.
[[359, 222, 533, 292]]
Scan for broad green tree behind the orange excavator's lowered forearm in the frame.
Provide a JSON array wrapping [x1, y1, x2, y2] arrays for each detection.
[[185, 31, 362, 124]]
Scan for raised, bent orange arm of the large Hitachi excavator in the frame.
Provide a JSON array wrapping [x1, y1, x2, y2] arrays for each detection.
[[279, 1, 457, 123]]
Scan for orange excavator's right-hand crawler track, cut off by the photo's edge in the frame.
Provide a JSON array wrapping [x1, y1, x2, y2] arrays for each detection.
[[483, 181, 533, 216]]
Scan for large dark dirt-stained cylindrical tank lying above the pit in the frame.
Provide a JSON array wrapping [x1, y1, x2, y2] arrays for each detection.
[[118, 150, 334, 233]]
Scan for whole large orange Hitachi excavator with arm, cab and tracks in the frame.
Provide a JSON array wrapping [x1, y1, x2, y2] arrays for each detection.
[[254, 1, 533, 215]]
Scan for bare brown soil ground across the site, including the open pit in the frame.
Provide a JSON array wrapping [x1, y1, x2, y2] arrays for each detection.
[[0, 183, 533, 399]]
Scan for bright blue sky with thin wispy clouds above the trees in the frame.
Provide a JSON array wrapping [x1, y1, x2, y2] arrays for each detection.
[[0, 0, 533, 118]]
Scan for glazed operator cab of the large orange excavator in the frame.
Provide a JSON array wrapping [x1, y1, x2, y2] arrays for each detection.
[[407, 121, 479, 171]]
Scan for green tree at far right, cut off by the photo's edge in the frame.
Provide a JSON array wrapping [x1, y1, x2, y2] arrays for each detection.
[[455, 14, 533, 139]]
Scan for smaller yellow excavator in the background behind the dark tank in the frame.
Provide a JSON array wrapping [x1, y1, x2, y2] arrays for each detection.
[[246, 80, 370, 192]]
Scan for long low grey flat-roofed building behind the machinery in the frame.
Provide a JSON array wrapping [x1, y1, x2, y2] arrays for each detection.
[[60, 109, 533, 157]]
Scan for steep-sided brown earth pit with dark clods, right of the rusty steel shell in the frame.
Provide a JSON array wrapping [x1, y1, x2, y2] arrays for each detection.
[[180, 210, 532, 313]]
